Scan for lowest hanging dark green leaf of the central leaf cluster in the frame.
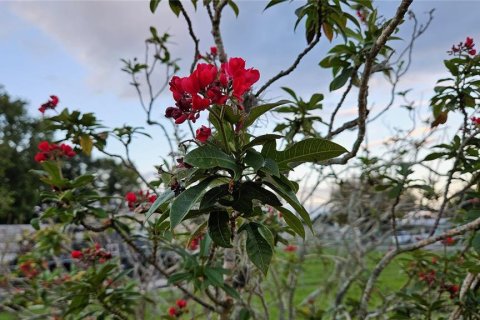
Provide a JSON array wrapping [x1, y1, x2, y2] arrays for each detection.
[[239, 222, 273, 275]]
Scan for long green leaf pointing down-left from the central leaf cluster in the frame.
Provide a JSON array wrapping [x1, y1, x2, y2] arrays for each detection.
[[170, 177, 216, 229]]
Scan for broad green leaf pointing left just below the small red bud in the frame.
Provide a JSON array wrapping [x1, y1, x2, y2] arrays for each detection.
[[184, 145, 238, 171]]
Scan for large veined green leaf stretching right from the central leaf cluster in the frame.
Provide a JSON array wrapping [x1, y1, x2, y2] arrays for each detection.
[[272, 138, 347, 170]]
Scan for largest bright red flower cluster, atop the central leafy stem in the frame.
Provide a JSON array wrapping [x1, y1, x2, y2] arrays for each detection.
[[165, 58, 260, 124]]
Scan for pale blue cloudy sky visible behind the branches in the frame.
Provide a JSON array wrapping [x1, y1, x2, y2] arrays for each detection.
[[0, 0, 480, 182]]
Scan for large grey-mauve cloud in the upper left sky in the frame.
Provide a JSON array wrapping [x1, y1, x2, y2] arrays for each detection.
[[9, 1, 204, 93]]
